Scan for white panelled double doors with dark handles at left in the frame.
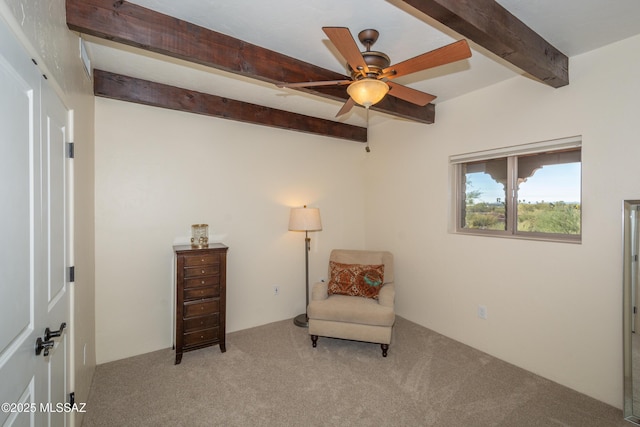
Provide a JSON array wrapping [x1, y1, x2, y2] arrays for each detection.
[[0, 20, 69, 426]]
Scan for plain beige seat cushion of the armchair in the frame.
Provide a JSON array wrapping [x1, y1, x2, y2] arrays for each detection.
[[308, 295, 396, 326]]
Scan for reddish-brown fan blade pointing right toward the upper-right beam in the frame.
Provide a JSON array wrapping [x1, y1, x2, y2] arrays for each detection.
[[382, 39, 471, 79]]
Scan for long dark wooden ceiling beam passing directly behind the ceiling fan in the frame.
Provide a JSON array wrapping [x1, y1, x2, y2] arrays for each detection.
[[66, 0, 435, 123]]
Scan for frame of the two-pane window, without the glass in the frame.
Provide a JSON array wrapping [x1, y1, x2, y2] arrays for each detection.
[[449, 135, 583, 243]]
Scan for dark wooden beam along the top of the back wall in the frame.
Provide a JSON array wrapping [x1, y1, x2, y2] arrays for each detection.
[[93, 70, 367, 142]]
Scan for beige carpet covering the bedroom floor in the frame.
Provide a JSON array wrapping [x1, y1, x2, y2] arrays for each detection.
[[83, 317, 630, 427]]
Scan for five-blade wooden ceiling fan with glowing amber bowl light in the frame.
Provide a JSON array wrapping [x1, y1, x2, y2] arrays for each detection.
[[277, 27, 471, 117]]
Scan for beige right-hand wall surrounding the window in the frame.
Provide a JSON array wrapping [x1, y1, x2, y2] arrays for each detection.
[[366, 37, 640, 407]]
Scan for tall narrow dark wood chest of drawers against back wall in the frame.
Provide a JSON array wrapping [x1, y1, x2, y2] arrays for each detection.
[[174, 243, 228, 365]]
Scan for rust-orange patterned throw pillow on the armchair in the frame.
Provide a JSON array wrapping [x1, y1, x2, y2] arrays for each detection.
[[328, 261, 384, 299]]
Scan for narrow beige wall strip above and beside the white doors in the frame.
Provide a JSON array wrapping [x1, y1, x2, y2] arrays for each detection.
[[0, 0, 96, 424]]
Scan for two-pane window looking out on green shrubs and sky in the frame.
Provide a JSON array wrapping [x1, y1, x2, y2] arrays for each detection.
[[450, 137, 582, 242]]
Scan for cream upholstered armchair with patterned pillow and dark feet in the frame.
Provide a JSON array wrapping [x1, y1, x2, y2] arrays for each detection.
[[307, 249, 396, 357]]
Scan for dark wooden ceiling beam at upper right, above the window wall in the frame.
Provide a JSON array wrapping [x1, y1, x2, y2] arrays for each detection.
[[402, 0, 569, 88]]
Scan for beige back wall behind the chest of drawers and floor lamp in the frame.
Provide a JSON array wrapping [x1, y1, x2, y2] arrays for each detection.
[[95, 98, 371, 363]]
